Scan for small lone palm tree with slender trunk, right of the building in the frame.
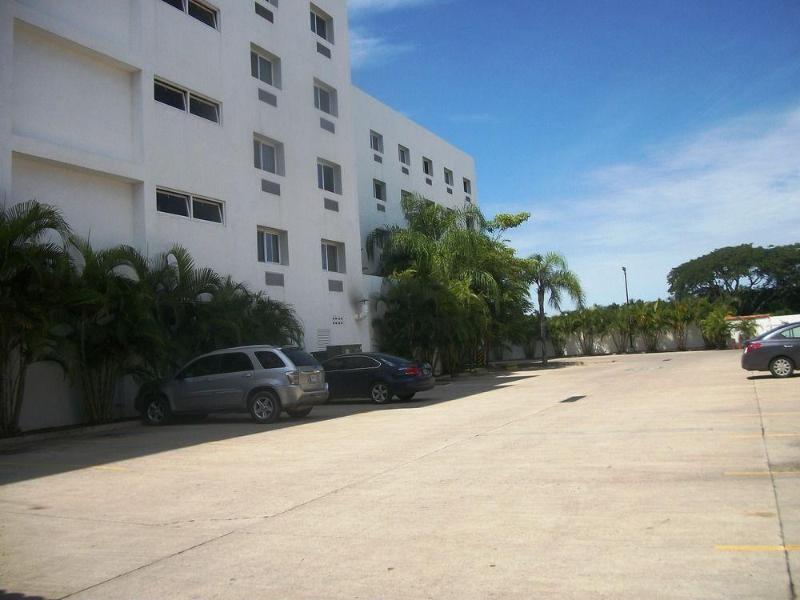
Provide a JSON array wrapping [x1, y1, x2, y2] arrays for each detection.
[[528, 252, 584, 365]]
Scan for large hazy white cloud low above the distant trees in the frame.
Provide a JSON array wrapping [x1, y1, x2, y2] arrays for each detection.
[[510, 109, 800, 303]]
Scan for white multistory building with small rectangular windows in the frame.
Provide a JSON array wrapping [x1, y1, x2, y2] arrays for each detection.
[[0, 0, 475, 426]]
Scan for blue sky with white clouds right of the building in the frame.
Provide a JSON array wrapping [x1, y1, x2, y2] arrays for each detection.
[[349, 0, 800, 304]]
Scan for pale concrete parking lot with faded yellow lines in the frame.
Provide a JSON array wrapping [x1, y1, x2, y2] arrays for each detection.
[[0, 351, 800, 599]]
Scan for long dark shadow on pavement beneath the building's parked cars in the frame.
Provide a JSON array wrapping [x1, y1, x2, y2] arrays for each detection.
[[0, 373, 535, 485]]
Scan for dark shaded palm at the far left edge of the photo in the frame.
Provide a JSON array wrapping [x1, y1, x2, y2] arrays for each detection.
[[0, 200, 69, 433]]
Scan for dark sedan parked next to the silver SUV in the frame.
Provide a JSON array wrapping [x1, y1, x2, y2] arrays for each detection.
[[322, 352, 436, 404]]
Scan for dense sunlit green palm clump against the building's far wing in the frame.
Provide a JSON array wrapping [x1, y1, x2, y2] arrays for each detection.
[[367, 195, 529, 372]]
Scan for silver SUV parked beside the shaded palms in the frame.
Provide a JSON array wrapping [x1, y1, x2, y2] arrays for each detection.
[[136, 346, 328, 425]]
